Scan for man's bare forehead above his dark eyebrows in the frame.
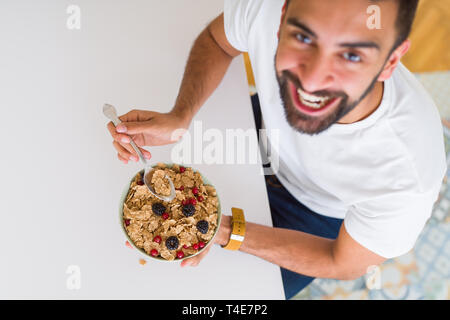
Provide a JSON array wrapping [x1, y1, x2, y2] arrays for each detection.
[[285, 0, 398, 47]]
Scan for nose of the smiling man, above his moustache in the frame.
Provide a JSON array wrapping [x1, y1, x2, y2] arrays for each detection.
[[297, 51, 333, 93]]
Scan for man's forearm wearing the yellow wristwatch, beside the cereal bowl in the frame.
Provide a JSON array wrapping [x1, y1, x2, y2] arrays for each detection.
[[217, 216, 345, 279]]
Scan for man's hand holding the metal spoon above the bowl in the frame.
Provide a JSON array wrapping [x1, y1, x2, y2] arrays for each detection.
[[107, 110, 190, 164]]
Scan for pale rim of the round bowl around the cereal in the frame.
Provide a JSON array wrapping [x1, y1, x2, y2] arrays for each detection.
[[119, 163, 222, 263]]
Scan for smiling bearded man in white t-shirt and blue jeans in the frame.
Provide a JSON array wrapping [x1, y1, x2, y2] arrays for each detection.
[[108, 0, 446, 299]]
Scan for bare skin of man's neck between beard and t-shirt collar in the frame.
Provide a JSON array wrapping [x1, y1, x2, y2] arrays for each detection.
[[337, 81, 384, 124]]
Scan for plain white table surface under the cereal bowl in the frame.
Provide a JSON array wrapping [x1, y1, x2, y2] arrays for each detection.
[[0, 0, 284, 299]]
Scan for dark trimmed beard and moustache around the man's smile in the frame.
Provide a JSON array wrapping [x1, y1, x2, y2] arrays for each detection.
[[275, 57, 382, 135]]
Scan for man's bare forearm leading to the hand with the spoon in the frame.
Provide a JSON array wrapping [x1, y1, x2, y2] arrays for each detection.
[[172, 24, 233, 123]]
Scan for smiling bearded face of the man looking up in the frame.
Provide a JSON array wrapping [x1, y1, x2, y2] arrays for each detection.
[[275, 0, 398, 134]]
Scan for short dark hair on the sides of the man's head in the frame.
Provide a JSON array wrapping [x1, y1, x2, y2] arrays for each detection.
[[286, 0, 419, 50]]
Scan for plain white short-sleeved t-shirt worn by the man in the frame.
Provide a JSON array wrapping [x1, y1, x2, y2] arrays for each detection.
[[224, 0, 447, 258]]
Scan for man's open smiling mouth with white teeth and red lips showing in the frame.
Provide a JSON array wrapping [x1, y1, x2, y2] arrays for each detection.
[[289, 81, 341, 115]]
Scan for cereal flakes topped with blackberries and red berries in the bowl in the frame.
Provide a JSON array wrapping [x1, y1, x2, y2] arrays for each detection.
[[123, 163, 219, 260]]
